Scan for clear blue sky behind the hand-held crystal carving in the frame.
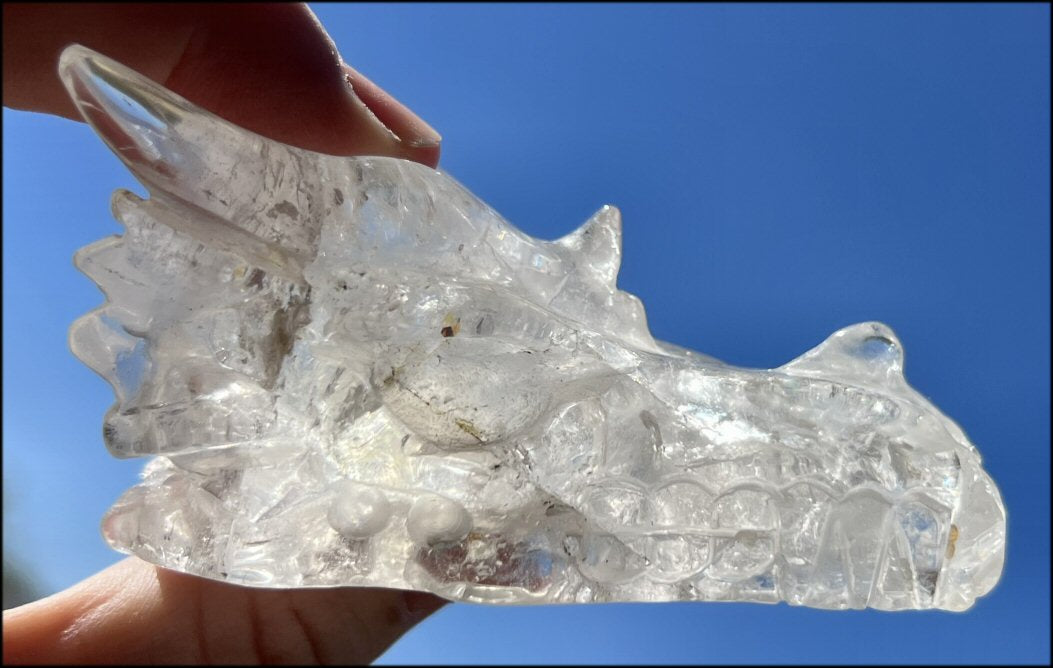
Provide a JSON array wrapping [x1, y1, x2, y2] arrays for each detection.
[[3, 4, 1050, 663]]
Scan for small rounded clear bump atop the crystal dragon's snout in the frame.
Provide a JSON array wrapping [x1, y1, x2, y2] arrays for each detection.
[[778, 322, 906, 388]]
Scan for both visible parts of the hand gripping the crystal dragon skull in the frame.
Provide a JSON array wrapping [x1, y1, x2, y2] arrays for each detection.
[[3, 3, 445, 664]]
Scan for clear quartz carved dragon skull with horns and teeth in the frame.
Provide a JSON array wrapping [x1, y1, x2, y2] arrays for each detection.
[[60, 46, 1006, 610]]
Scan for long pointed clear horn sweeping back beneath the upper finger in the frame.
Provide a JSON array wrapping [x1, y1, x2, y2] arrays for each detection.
[[59, 44, 329, 257]]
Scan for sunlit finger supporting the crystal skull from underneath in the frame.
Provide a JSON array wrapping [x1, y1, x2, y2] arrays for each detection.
[[3, 557, 445, 664]]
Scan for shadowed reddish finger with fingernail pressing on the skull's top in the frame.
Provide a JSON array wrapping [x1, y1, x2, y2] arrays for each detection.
[[3, 3, 440, 166]]
